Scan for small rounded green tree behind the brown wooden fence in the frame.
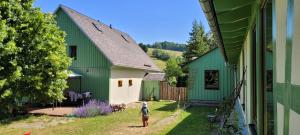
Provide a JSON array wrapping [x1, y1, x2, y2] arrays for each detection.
[[165, 58, 183, 86]]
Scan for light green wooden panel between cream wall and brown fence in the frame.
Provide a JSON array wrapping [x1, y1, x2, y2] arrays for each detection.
[[142, 80, 160, 99]]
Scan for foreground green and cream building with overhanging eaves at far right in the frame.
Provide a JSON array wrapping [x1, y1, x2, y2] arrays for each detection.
[[200, 0, 300, 135]]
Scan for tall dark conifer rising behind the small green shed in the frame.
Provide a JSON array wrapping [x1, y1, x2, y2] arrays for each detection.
[[183, 20, 209, 62]]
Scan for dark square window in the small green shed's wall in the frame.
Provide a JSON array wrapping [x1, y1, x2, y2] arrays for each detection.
[[204, 70, 220, 90]]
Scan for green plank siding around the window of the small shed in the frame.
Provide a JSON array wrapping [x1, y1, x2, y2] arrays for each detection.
[[188, 49, 234, 101]]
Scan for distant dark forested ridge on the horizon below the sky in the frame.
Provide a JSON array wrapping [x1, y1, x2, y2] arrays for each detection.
[[140, 41, 186, 52]]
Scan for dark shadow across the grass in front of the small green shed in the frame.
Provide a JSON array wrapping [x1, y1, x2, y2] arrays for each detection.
[[167, 106, 215, 135]]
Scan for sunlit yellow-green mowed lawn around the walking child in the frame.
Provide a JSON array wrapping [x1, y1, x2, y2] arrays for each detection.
[[0, 101, 177, 135]]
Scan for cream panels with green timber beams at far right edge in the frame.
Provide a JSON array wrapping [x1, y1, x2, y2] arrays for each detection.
[[272, 0, 300, 135]]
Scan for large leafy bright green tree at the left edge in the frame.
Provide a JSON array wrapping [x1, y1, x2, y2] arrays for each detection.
[[0, 0, 71, 113]]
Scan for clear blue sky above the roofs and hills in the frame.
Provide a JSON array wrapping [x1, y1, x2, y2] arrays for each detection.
[[34, 0, 209, 44]]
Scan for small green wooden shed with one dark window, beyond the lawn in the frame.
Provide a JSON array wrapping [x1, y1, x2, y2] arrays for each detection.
[[185, 48, 234, 103]]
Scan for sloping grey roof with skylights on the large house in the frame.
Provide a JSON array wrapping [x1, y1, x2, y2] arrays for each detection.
[[59, 5, 160, 71]]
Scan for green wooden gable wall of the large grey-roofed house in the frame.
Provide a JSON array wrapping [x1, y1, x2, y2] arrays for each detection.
[[56, 9, 111, 100]]
